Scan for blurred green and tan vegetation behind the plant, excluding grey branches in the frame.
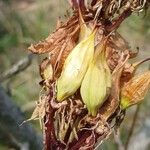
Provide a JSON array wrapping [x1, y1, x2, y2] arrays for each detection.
[[0, 0, 150, 150]]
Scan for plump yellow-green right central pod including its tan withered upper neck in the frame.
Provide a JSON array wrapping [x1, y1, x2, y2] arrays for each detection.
[[80, 39, 111, 116]]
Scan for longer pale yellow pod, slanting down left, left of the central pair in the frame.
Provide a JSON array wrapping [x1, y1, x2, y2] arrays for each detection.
[[57, 31, 95, 102]]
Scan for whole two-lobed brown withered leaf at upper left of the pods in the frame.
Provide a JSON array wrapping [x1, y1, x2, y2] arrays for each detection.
[[28, 14, 79, 77]]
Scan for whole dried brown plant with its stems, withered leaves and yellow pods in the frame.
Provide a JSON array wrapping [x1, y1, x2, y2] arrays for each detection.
[[26, 0, 150, 150]]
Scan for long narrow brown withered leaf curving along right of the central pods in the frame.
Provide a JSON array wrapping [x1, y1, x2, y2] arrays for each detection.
[[99, 53, 129, 121]]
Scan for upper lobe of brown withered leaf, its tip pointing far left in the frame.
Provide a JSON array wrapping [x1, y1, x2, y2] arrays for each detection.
[[28, 14, 78, 54]]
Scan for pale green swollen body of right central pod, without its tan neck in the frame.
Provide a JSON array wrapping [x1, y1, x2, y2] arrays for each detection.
[[81, 63, 106, 116]]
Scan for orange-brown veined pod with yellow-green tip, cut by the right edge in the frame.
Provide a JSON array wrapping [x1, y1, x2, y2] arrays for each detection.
[[120, 71, 150, 109]]
